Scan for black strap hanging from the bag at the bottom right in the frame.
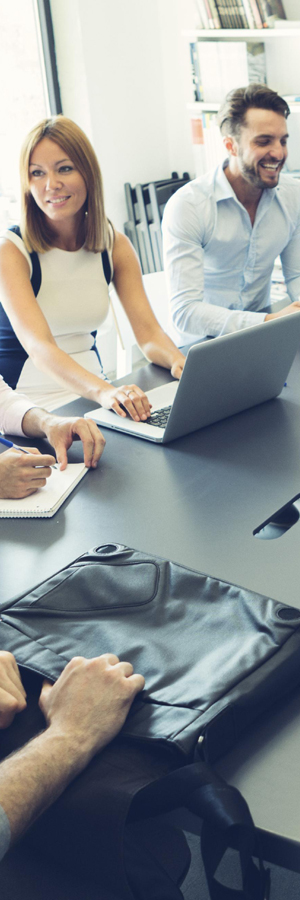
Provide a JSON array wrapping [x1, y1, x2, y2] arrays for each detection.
[[130, 761, 270, 900]]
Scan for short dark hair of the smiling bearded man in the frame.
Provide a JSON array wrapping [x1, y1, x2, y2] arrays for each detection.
[[218, 83, 290, 137]]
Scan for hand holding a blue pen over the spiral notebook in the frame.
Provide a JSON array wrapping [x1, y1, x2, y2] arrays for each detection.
[[0, 447, 55, 500]]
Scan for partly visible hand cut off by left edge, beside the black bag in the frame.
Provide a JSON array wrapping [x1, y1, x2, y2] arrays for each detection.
[[0, 650, 26, 728]]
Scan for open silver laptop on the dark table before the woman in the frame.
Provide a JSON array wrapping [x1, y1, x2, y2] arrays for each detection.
[[85, 312, 300, 444]]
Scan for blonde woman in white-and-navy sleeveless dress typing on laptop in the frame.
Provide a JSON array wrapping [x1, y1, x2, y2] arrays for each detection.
[[0, 116, 184, 421]]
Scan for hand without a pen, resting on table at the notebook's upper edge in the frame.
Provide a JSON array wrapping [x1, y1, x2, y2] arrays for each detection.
[[39, 416, 105, 470]]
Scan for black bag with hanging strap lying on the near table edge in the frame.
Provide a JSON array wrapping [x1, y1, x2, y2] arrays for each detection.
[[1, 544, 300, 900]]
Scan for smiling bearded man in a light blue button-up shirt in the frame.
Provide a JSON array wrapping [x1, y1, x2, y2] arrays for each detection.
[[163, 84, 300, 338]]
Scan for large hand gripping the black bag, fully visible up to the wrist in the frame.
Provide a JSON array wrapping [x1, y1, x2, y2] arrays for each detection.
[[39, 653, 145, 765]]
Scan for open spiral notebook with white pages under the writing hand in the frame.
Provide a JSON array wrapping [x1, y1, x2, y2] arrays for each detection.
[[0, 463, 88, 519]]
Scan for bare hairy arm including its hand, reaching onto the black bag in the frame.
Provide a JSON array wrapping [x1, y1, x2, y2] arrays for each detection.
[[0, 653, 144, 847]]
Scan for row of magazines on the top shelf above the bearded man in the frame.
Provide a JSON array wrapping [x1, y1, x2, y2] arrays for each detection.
[[195, 0, 286, 30]]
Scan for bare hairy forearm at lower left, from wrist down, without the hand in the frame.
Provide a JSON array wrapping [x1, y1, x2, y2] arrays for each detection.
[[0, 728, 88, 842]]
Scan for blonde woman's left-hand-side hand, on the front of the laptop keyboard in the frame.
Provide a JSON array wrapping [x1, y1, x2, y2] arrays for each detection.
[[98, 384, 151, 422]]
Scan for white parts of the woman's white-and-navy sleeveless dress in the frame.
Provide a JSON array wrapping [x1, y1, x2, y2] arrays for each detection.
[[4, 231, 113, 410]]
